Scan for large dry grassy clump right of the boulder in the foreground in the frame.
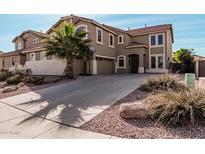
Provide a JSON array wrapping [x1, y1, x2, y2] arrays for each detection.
[[147, 89, 205, 127]]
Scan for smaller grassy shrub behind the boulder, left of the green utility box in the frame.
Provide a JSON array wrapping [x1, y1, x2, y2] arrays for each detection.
[[139, 74, 186, 92]]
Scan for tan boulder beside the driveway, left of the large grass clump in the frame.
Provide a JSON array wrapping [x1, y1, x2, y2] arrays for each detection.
[[119, 102, 149, 119]]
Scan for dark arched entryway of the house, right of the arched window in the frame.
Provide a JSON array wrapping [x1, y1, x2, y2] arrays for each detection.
[[129, 54, 139, 73]]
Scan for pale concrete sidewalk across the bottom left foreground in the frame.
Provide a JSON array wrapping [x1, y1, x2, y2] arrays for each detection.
[[0, 102, 116, 139]]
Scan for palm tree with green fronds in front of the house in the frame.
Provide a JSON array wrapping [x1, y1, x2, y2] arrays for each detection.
[[45, 22, 92, 79]]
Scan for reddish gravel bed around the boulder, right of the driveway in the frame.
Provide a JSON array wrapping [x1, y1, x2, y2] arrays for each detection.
[[80, 89, 205, 139]]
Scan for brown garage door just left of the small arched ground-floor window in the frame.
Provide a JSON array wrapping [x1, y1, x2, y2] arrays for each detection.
[[96, 57, 115, 75]]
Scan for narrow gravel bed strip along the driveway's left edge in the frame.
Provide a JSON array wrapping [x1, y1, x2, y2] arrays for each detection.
[[0, 80, 71, 99]]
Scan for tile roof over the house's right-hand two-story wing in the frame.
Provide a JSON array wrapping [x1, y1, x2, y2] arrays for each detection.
[[127, 24, 172, 36]]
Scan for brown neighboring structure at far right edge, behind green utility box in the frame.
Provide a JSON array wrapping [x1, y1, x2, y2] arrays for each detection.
[[194, 55, 205, 77]]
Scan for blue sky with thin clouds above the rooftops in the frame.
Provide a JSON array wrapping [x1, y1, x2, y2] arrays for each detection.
[[0, 14, 205, 56]]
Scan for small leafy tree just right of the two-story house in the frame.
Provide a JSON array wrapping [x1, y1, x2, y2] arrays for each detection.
[[172, 48, 194, 73]]
